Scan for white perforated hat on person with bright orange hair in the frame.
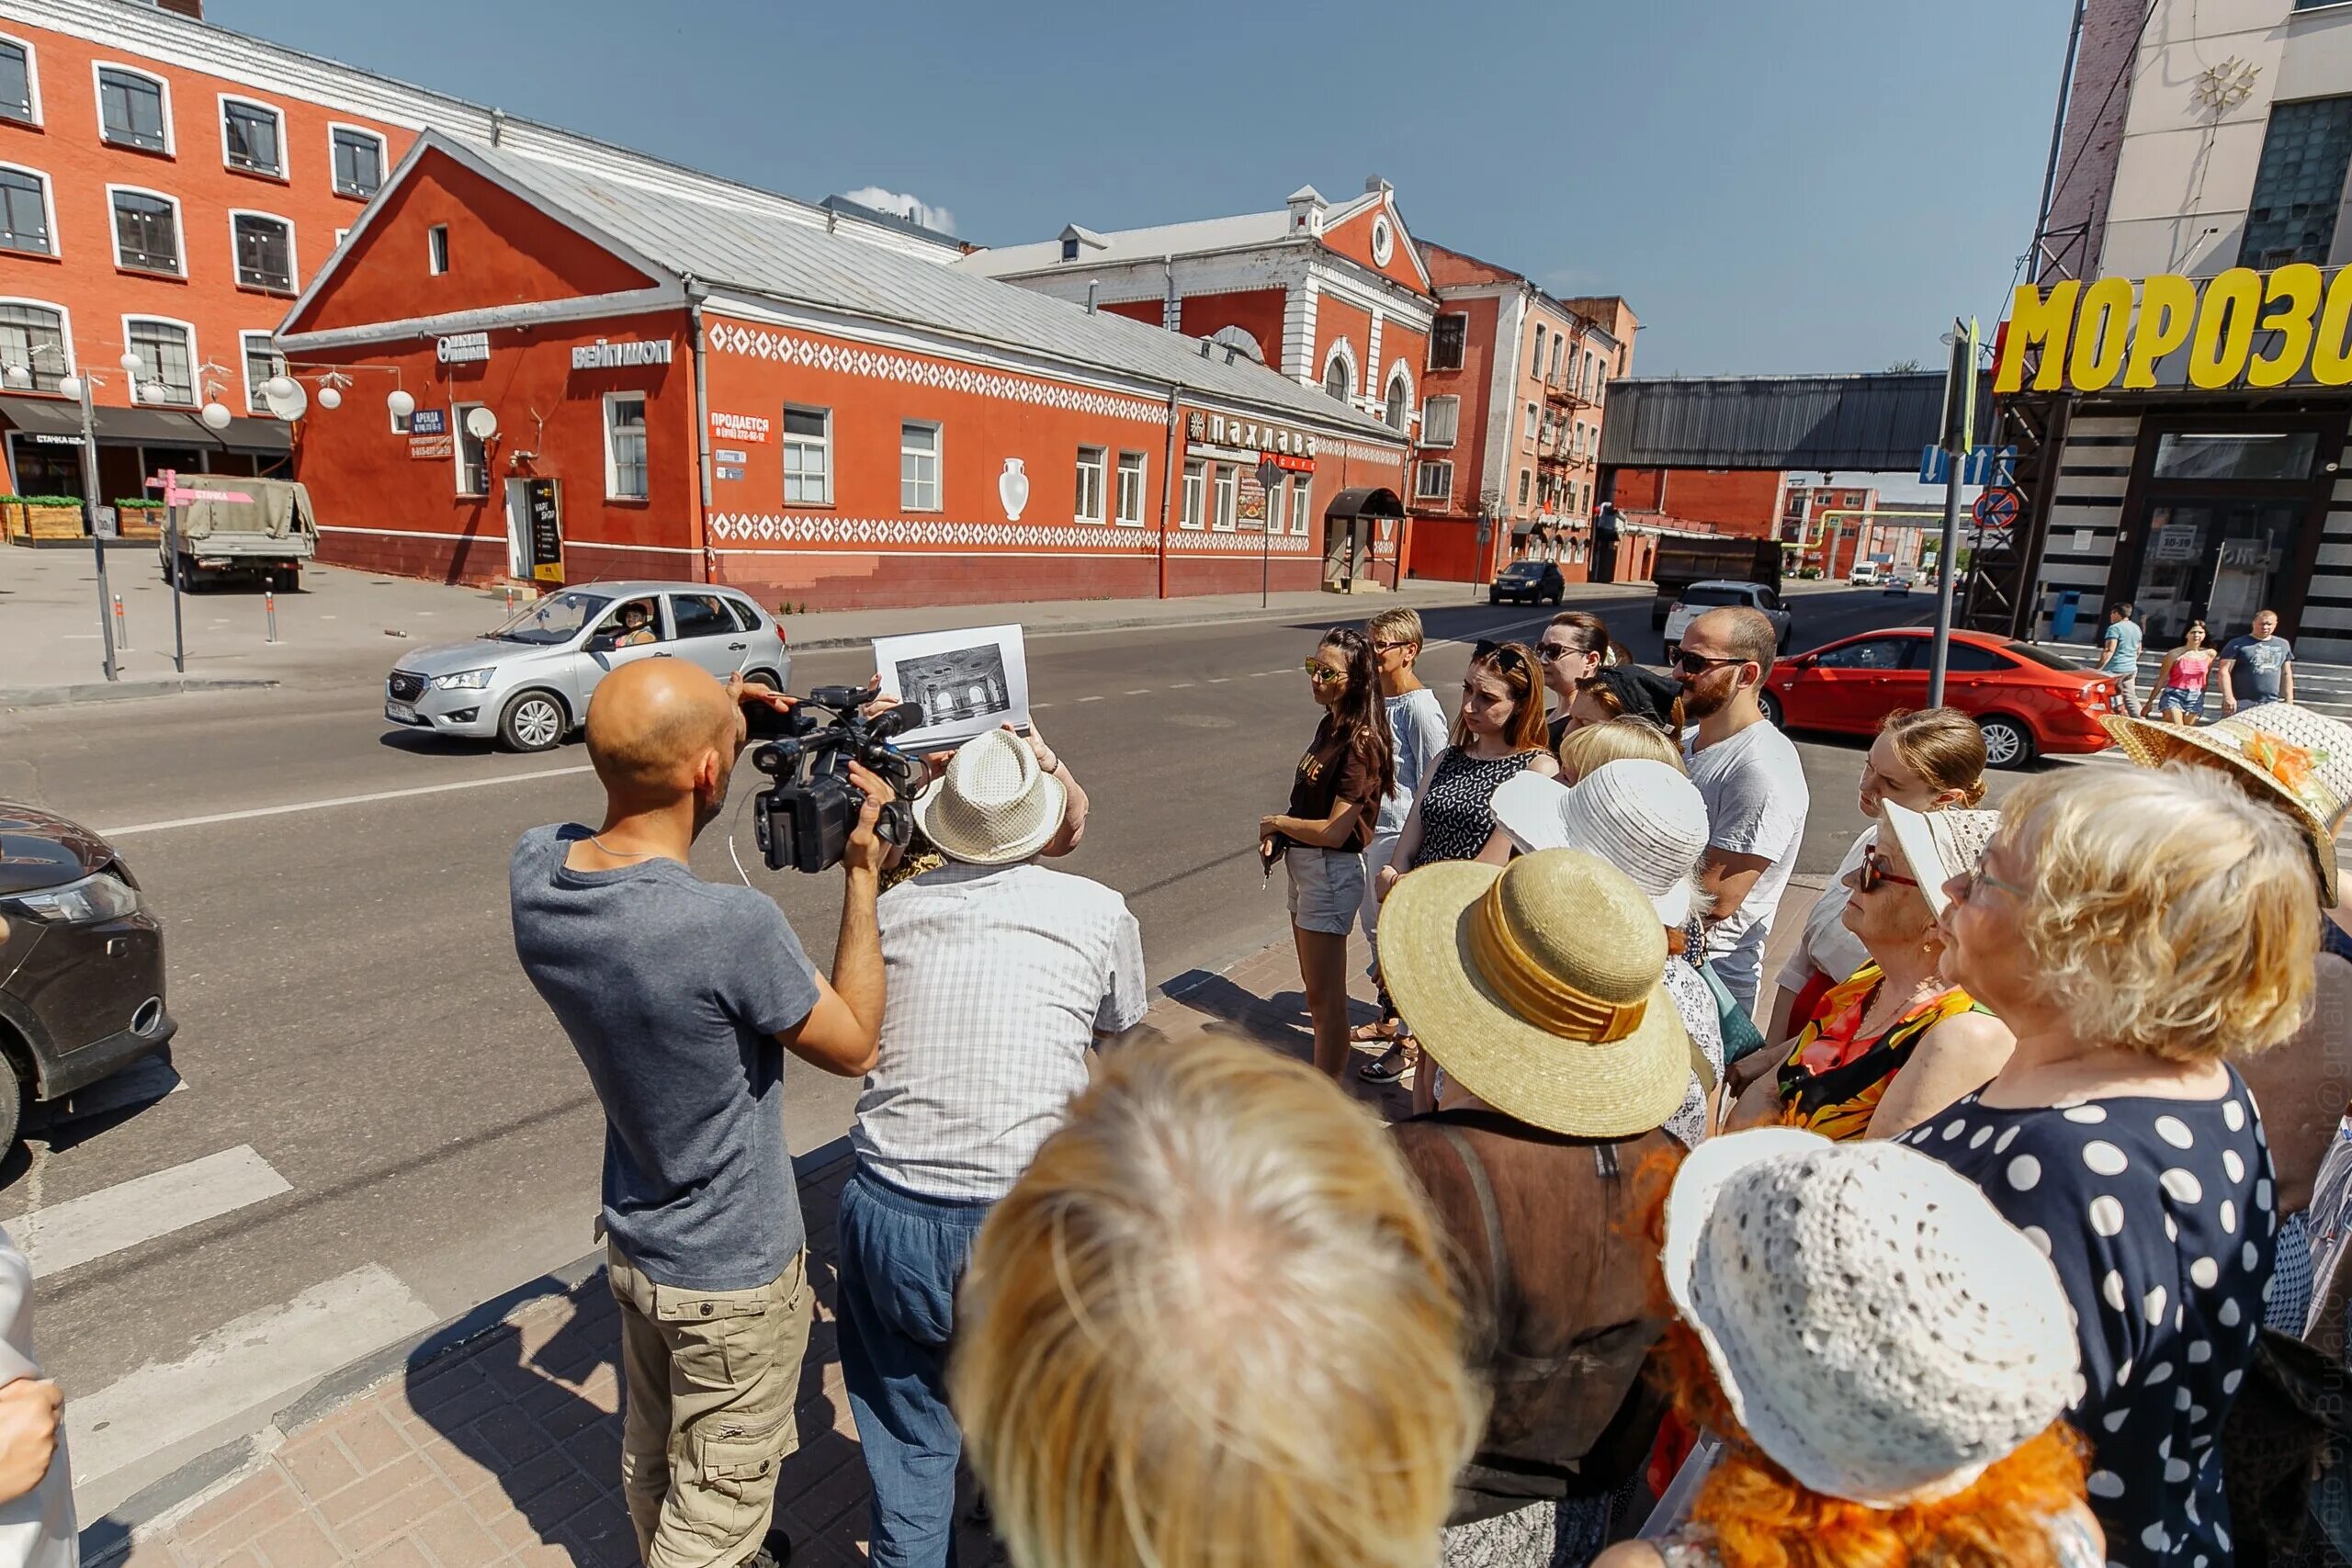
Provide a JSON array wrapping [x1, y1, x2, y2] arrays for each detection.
[[1660, 1128, 2079, 1509]]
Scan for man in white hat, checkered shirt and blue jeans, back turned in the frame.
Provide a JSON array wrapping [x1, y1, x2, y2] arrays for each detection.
[[837, 728, 1146, 1568]]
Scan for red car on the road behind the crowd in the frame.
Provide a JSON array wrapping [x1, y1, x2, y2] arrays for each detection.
[[1761, 626, 2114, 769]]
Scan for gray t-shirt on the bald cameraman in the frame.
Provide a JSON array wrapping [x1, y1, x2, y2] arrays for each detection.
[[508, 823, 819, 1291]]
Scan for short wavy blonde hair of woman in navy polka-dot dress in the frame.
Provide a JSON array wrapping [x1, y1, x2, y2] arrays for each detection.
[[1995, 766, 2319, 1063]]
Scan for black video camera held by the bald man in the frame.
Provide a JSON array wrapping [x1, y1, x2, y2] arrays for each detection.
[[746, 686, 922, 872]]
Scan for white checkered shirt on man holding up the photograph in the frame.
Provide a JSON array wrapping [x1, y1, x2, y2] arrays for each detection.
[[849, 863, 1146, 1199]]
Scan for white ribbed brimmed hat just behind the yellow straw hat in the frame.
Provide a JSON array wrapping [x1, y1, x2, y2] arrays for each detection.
[[1494, 760, 1708, 926]]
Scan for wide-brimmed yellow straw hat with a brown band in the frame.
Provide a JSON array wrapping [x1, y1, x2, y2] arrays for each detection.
[[1381, 849, 1691, 1138]]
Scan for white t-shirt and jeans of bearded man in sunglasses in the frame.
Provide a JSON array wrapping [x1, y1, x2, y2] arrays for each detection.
[[1681, 722, 1814, 1009]]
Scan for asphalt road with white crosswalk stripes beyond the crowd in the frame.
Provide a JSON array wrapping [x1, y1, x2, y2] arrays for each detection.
[[0, 590, 2022, 1518]]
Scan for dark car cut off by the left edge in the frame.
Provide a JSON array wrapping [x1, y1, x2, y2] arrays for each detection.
[[0, 802, 179, 1152]]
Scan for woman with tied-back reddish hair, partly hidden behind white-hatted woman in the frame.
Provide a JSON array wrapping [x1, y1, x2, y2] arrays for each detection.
[[1764, 707, 1985, 1046]]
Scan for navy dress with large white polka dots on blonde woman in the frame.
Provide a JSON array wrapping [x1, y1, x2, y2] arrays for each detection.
[[1903, 1072, 2279, 1568]]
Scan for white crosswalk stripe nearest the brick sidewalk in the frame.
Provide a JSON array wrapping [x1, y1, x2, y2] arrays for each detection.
[[66, 1262, 437, 1518]]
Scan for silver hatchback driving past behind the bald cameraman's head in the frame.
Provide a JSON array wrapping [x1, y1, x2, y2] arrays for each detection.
[[383, 583, 793, 752]]
